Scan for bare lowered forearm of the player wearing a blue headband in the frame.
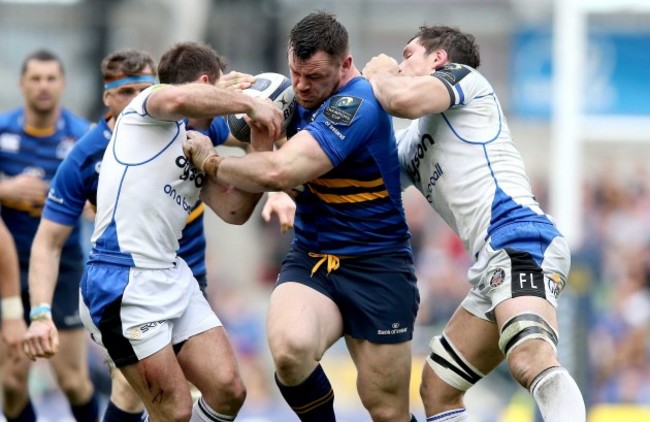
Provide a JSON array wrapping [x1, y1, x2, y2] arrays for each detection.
[[29, 218, 73, 306]]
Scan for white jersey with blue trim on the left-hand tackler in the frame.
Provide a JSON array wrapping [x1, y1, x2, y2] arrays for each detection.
[[89, 86, 204, 268]]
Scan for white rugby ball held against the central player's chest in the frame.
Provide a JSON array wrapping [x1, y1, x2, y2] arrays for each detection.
[[226, 72, 296, 142]]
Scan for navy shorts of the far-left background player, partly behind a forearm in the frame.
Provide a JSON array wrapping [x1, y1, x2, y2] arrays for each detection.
[[20, 247, 84, 330]]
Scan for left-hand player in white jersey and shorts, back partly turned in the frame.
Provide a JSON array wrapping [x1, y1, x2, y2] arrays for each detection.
[[74, 43, 283, 421]]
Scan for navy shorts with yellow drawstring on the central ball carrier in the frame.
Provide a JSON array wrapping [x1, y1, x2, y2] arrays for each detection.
[[276, 248, 420, 343]]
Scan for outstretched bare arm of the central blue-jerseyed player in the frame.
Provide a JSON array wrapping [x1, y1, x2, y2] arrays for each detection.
[[210, 130, 334, 192]]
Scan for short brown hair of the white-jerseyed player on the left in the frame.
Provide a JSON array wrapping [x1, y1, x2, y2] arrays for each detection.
[[158, 42, 226, 84]]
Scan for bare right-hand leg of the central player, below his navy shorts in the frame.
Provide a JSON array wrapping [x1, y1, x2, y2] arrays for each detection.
[[345, 336, 412, 409]]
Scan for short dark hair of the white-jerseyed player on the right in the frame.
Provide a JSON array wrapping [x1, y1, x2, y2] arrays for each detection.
[[409, 25, 481, 69]]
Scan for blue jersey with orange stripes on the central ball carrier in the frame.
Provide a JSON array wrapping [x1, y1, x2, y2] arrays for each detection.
[[287, 77, 411, 256]]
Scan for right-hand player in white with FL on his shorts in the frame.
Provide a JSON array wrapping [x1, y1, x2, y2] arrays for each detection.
[[363, 26, 585, 422]]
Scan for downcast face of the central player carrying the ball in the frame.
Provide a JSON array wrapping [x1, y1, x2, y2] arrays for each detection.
[[289, 51, 342, 109]]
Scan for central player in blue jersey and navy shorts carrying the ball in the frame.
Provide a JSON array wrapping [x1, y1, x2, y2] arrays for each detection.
[[186, 12, 419, 422]]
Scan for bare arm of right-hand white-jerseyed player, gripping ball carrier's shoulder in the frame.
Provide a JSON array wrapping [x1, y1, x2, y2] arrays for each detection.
[[369, 73, 451, 119]]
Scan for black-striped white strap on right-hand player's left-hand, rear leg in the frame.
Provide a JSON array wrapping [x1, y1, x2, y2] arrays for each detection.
[[427, 334, 485, 391]]
